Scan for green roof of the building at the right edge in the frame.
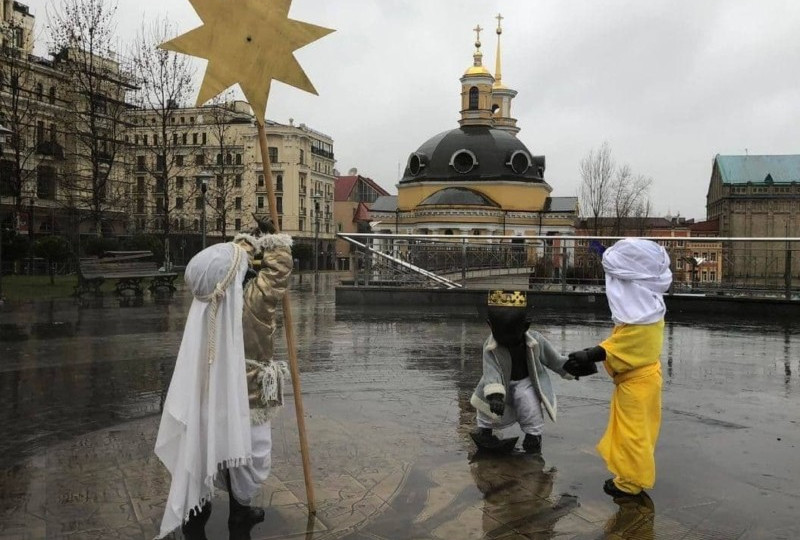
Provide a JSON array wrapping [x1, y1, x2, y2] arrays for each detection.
[[716, 154, 800, 184]]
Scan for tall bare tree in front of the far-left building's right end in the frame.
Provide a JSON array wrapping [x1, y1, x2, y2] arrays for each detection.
[[48, 0, 134, 235]]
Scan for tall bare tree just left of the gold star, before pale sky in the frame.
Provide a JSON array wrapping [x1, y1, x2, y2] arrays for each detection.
[[131, 19, 194, 263]]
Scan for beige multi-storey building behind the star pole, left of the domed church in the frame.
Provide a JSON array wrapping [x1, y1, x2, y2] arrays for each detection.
[[128, 102, 336, 268]]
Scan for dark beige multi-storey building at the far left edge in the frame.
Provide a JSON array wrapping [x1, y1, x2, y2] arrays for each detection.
[[0, 0, 133, 247]]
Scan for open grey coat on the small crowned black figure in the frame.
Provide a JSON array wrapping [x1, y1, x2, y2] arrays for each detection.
[[470, 330, 574, 425]]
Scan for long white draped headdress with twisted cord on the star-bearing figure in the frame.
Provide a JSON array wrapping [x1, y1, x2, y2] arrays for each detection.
[[155, 243, 253, 538]]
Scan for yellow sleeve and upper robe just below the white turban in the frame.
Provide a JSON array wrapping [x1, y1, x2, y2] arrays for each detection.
[[600, 319, 664, 375]]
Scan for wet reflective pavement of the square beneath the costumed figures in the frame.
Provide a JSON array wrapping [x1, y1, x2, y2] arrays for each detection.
[[0, 275, 800, 540]]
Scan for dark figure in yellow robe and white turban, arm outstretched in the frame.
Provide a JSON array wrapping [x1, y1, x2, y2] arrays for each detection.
[[564, 238, 672, 497]]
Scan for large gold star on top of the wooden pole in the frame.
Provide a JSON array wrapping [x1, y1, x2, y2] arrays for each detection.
[[160, 0, 333, 124]]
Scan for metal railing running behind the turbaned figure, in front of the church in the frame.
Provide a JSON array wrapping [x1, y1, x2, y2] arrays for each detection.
[[338, 233, 800, 299]]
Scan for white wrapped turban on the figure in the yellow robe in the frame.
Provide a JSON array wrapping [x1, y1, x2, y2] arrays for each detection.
[[603, 238, 672, 324]]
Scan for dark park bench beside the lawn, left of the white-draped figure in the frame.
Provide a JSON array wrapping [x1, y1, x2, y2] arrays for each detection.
[[75, 251, 178, 297]]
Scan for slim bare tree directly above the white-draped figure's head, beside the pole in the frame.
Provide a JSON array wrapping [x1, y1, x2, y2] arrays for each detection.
[[206, 92, 249, 242]]
